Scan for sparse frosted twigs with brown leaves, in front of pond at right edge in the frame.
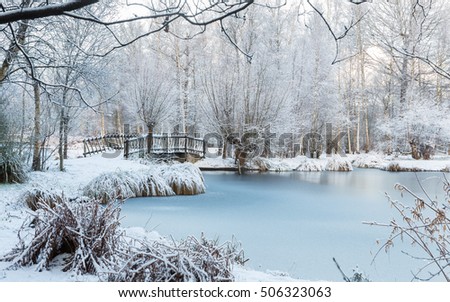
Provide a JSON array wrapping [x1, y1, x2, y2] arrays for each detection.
[[368, 175, 450, 281]]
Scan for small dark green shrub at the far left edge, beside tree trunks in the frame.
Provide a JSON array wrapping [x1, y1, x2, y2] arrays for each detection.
[[0, 153, 27, 183]]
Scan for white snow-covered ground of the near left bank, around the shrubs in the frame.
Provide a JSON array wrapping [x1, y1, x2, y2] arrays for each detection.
[[0, 155, 293, 282]]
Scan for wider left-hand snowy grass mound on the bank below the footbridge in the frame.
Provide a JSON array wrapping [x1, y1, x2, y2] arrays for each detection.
[[83, 170, 175, 204]]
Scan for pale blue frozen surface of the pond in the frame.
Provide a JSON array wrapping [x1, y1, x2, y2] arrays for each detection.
[[122, 169, 442, 281]]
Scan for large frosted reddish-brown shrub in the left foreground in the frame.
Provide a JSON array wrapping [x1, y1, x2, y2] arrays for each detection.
[[3, 198, 121, 274]]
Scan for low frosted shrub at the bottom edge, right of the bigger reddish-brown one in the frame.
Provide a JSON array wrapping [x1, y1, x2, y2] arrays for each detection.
[[107, 236, 245, 282]]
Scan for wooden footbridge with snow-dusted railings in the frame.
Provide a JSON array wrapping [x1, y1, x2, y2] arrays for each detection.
[[83, 134, 206, 160]]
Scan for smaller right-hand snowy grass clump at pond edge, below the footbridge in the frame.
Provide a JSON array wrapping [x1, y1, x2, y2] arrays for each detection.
[[161, 163, 206, 195]]
